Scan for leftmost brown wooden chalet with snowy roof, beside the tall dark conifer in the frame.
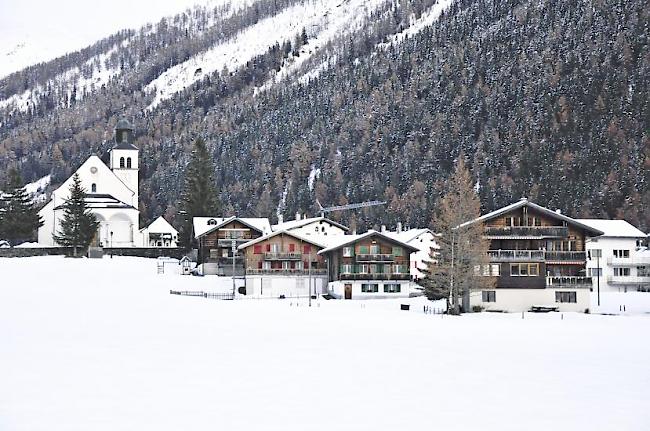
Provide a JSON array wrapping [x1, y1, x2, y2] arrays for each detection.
[[192, 217, 271, 276]]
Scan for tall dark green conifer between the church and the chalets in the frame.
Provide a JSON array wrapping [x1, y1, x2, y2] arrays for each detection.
[[179, 138, 220, 248]]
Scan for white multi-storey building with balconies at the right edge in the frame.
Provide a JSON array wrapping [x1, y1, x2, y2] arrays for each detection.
[[578, 219, 650, 292]]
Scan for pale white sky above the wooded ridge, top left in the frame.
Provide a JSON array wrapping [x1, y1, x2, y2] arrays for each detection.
[[0, 0, 227, 78]]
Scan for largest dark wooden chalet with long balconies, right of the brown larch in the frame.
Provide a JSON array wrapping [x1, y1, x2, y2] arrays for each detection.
[[461, 198, 603, 312]]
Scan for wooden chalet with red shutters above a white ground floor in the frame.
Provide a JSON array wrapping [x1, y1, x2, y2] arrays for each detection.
[[239, 230, 327, 297]]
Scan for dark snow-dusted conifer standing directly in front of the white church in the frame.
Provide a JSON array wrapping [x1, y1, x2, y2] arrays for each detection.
[[53, 174, 99, 256]]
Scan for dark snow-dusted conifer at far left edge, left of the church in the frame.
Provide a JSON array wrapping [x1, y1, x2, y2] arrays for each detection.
[[0, 169, 43, 246]]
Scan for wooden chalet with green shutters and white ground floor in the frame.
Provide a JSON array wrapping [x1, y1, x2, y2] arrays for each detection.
[[318, 230, 418, 299]]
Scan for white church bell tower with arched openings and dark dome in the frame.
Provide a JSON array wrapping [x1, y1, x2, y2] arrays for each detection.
[[110, 119, 139, 209]]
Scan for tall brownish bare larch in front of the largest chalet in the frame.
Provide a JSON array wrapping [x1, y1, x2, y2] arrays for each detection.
[[424, 155, 495, 314]]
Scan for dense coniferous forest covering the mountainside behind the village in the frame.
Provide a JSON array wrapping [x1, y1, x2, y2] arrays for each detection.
[[0, 0, 650, 232]]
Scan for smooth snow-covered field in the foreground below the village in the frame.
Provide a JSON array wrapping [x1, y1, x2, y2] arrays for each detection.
[[0, 257, 650, 431]]
